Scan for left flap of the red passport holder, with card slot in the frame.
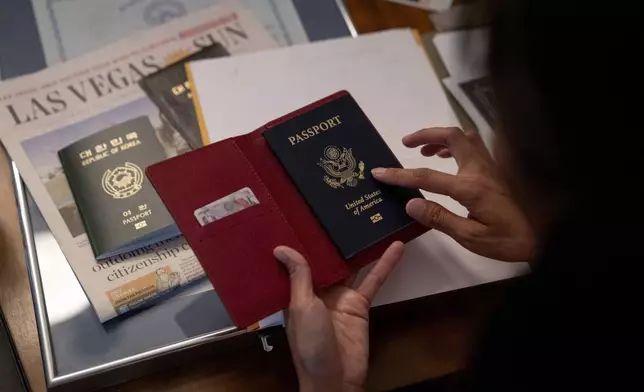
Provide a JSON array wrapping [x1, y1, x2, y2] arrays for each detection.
[[147, 139, 309, 326]]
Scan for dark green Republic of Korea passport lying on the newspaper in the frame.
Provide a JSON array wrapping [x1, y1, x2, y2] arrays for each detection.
[[58, 116, 180, 259]]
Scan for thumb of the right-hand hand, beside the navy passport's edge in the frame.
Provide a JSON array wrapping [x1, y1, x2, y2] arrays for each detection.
[[405, 199, 483, 243]]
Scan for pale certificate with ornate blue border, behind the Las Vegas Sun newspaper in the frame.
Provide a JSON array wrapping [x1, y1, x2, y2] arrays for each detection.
[[31, 0, 308, 66]]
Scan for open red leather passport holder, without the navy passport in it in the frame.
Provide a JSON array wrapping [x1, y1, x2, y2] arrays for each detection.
[[146, 91, 426, 328]]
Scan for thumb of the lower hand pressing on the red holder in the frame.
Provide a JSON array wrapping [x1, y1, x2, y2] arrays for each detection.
[[273, 246, 315, 305]]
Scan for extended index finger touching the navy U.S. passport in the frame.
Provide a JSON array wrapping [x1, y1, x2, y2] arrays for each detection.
[[371, 167, 462, 199]]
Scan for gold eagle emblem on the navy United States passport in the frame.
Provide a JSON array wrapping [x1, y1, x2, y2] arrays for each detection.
[[318, 146, 364, 189]]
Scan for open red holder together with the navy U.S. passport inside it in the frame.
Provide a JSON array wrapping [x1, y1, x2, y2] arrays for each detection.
[[146, 91, 427, 327]]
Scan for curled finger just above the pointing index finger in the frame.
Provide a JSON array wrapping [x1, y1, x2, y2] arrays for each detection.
[[402, 127, 472, 165]]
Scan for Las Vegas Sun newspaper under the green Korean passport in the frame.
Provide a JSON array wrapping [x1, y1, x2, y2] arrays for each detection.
[[0, 4, 277, 322]]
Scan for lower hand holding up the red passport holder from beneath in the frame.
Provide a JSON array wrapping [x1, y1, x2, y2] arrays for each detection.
[[274, 242, 404, 391]]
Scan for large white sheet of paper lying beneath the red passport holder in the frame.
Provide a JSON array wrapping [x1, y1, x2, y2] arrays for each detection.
[[191, 30, 528, 305]]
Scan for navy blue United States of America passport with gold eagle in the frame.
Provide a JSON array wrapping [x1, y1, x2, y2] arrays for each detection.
[[264, 94, 423, 259]]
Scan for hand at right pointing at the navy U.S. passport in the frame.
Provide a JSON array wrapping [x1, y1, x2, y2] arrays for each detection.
[[372, 128, 535, 261]]
